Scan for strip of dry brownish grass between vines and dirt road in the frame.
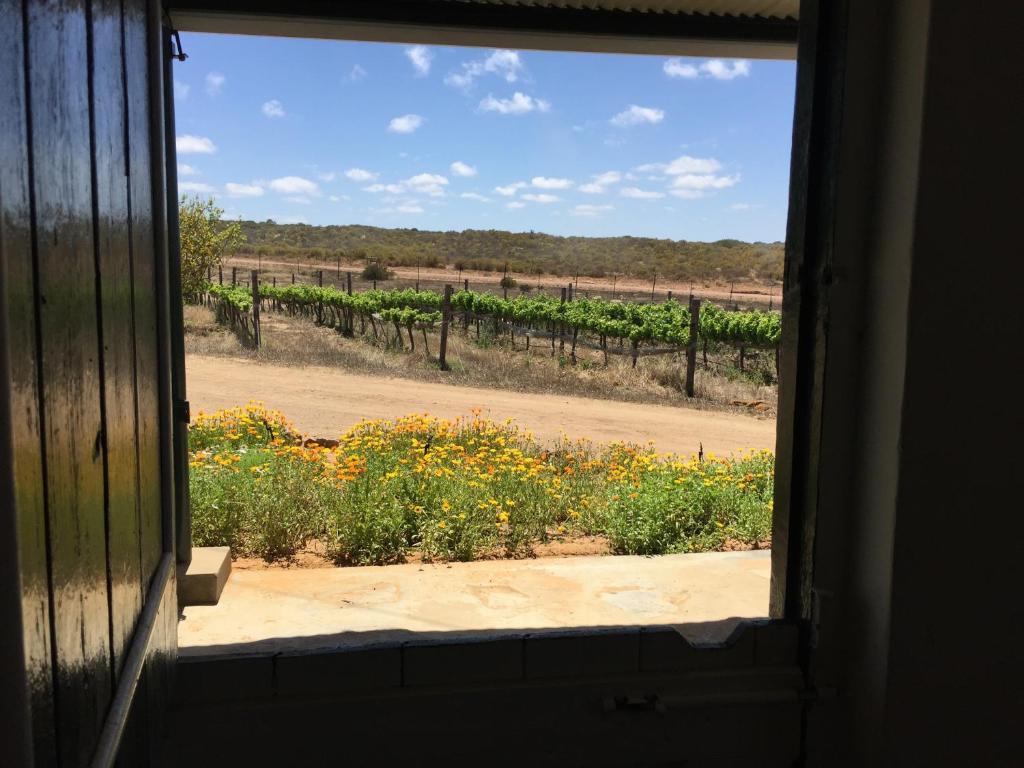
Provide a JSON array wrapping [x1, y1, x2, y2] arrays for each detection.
[[184, 306, 777, 418]]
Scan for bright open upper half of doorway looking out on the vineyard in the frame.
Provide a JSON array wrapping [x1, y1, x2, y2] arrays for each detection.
[[168, 4, 803, 655]]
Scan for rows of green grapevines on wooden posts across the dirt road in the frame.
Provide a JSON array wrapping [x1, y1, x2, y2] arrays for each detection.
[[199, 275, 781, 387]]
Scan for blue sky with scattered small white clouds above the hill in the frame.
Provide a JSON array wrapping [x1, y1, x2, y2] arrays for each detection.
[[174, 34, 796, 241]]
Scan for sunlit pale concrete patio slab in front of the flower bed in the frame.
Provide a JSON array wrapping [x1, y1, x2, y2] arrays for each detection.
[[178, 551, 771, 656]]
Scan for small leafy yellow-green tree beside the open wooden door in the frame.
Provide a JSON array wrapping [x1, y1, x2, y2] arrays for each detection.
[[178, 196, 246, 297]]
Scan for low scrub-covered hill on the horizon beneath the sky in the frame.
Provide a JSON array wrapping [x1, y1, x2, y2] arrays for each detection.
[[235, 220, 783, 282]]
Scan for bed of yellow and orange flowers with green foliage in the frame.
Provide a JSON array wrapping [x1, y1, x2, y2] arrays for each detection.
[[189, 403, 773, 564]]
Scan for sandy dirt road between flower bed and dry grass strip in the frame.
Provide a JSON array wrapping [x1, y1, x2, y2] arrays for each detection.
[[186, 355, 775, 454]]
